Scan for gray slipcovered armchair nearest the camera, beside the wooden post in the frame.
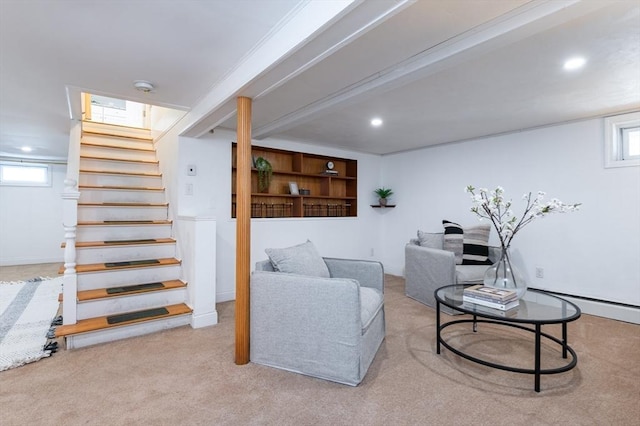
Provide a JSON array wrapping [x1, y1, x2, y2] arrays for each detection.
[[250, 258, 385, 386]]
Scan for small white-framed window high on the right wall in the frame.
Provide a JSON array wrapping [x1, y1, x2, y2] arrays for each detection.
[[604, 112, 640, 168]]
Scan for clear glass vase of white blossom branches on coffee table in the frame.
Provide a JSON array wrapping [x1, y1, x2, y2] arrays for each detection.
[[466, 185, 580, 299]]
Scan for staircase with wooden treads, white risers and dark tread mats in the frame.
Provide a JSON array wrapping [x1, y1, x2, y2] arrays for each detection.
[[55, 122, 192, 348]]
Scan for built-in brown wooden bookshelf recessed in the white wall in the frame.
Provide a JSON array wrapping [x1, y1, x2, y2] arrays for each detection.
[[231, 143, 358, 218]]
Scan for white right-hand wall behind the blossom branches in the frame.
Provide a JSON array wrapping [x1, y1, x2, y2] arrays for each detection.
[[381, 119, 640, 306]]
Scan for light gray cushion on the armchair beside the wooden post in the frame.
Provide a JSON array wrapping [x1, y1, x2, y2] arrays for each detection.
[[265, 240, 330, 278]]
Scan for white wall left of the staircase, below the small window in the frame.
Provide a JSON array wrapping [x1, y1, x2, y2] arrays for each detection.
[[0, 164, 66, 266]]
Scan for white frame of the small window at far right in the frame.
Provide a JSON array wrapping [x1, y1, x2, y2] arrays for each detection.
[[604, 112, 640, 168]]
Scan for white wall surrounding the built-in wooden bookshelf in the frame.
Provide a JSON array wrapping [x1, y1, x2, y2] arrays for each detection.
[[174, 130, 382, 302]]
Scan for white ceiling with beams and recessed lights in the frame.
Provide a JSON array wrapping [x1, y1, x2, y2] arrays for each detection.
[[0, 0, 640, 158]]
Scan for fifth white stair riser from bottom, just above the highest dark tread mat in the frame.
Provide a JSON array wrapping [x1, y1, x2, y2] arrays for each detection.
[[76, 224, 171, 241]]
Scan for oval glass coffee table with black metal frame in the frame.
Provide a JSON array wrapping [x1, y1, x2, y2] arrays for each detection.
[[434, 285, 581, 392]]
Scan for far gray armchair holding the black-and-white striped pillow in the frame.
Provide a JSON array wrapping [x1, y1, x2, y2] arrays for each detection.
[[404, 233, 500, 313]]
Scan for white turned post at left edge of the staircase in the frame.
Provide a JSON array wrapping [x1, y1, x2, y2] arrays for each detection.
[[62, 121, 82, 325]]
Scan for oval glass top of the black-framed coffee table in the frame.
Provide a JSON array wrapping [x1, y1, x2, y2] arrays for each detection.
[[435, 285, 580, 324]]
